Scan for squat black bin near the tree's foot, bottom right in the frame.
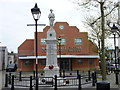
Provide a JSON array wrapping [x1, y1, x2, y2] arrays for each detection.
[[96, 82, 110, 90]]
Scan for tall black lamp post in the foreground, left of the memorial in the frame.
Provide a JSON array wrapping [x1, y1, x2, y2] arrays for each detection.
[[31, 3, 41, 90]]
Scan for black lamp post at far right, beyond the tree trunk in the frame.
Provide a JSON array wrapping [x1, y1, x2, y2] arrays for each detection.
[[111, 24, 118, 84]]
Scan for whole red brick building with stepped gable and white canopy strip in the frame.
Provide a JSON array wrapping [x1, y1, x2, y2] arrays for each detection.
[[18, 22, 99, 71]]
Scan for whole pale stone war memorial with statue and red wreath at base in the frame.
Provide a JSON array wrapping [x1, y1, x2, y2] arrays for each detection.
[[44, 9, 59, 77]]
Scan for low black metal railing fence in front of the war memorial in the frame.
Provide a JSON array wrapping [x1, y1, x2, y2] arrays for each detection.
[[5, 71, 97, 90]]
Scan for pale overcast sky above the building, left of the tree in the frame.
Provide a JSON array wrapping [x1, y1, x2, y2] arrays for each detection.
[[0, 0, 85, 52]]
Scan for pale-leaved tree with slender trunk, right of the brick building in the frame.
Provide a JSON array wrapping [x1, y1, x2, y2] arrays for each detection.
[[72, 0, 118, 80]]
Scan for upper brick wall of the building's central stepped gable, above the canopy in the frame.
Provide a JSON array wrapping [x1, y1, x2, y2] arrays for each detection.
[[38, 22, 90, 55]]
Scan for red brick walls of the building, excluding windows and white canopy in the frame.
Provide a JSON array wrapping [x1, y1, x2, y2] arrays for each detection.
[[18, 22, 98, 70]]
